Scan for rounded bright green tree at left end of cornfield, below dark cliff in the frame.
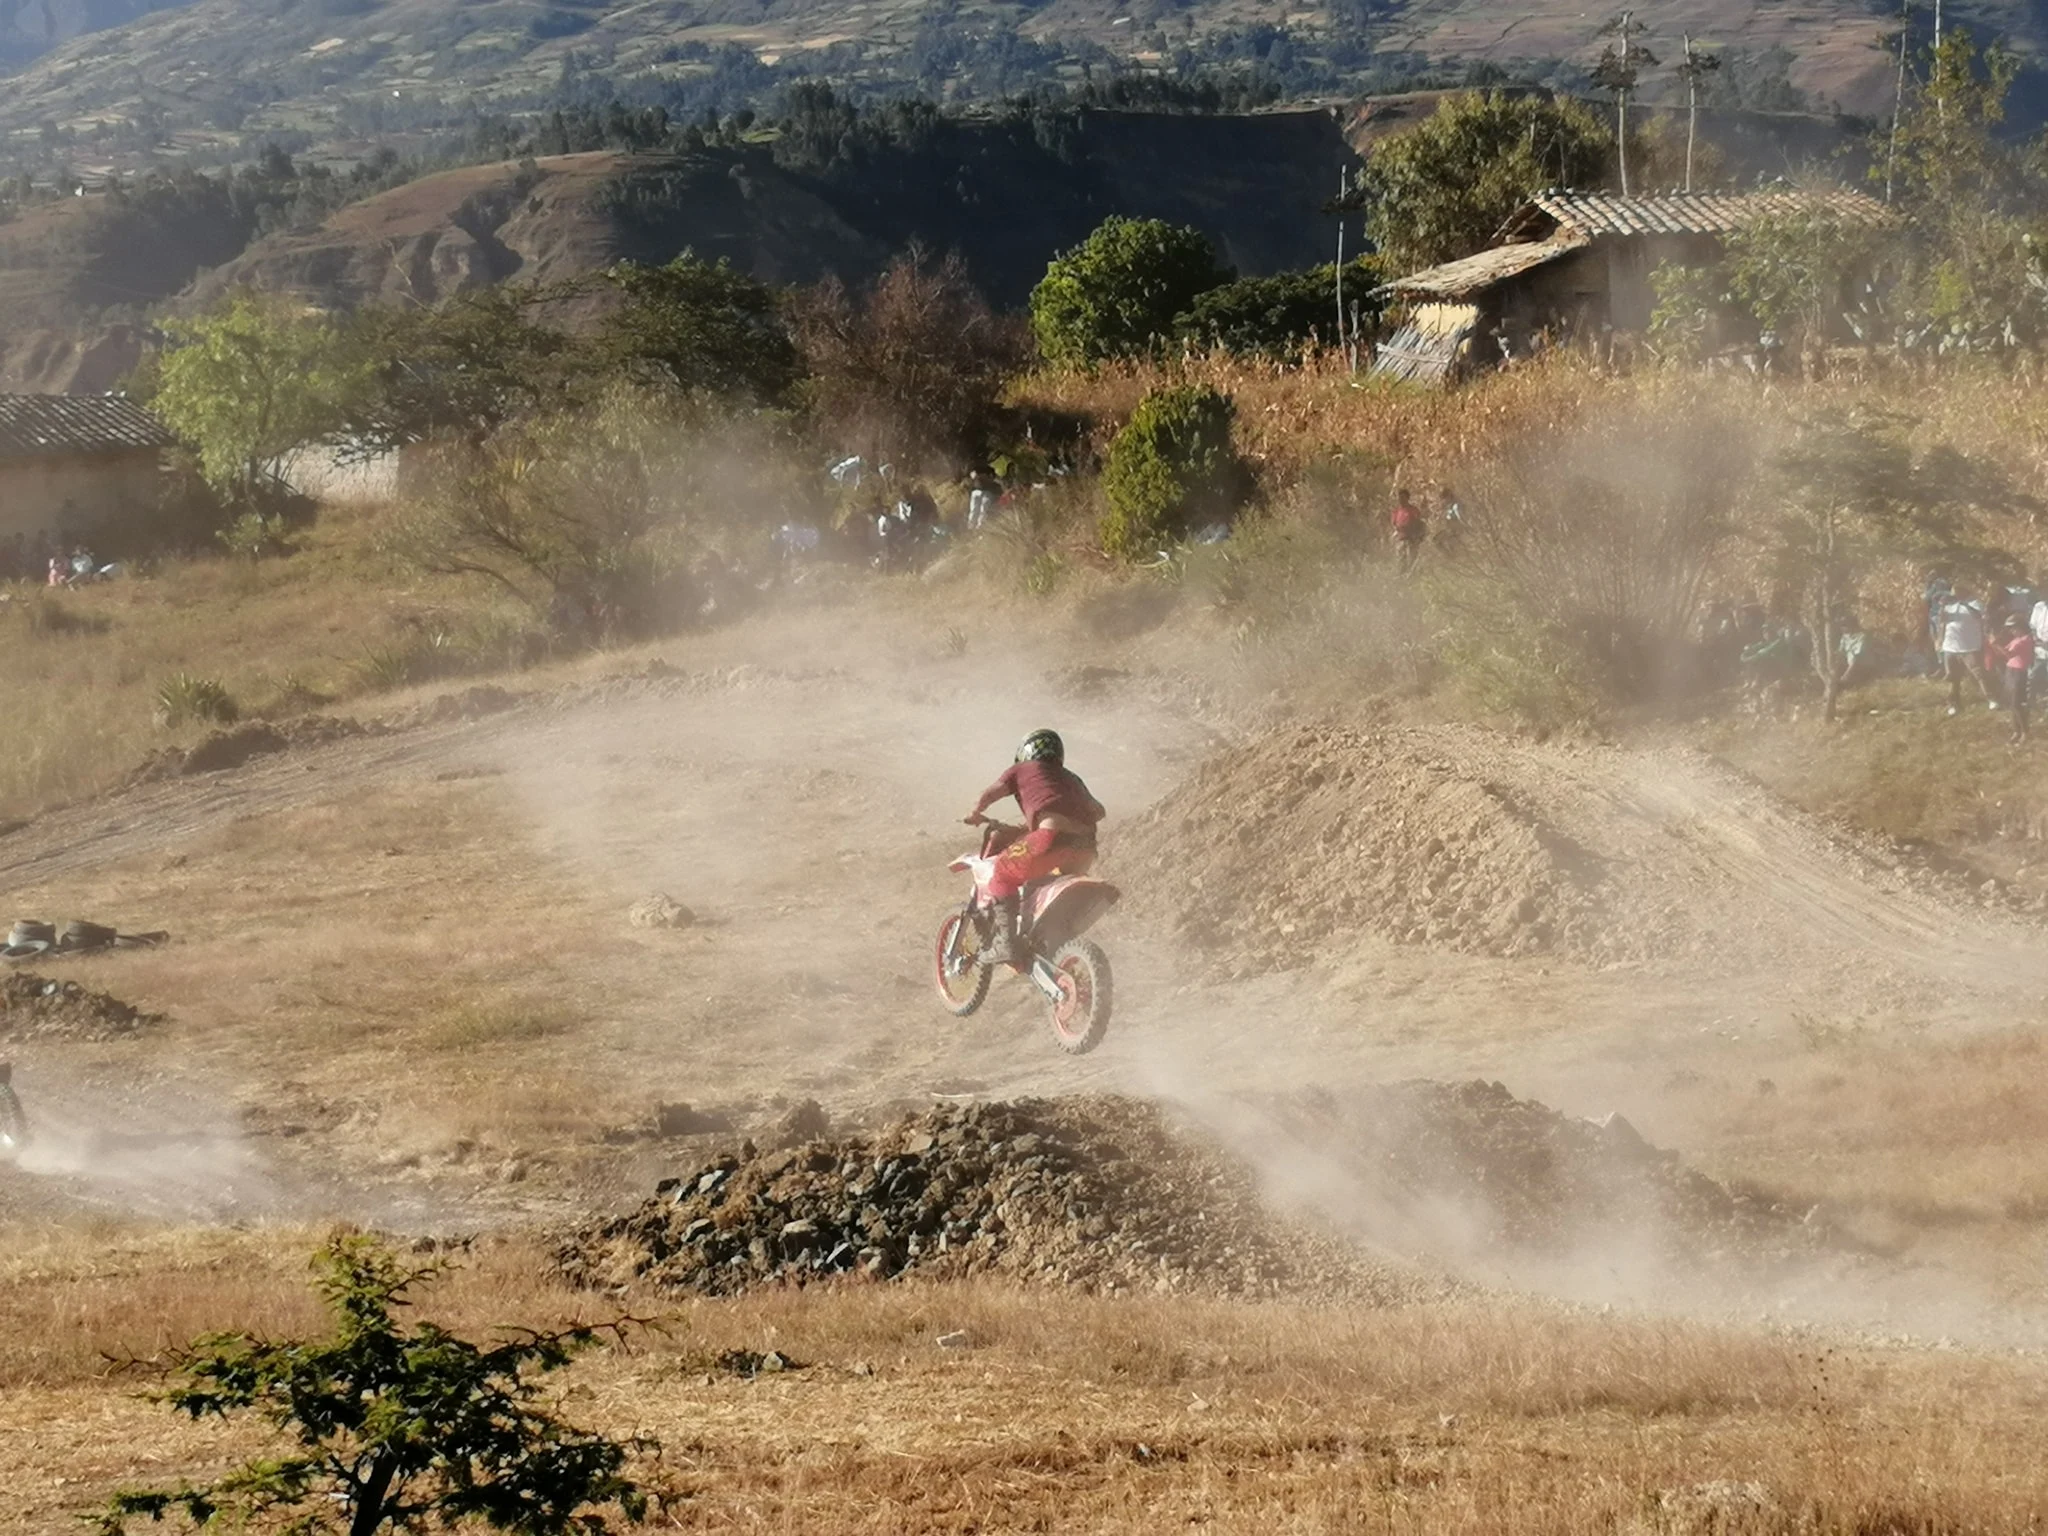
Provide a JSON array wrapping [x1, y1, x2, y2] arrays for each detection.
[[1030, 217, 1231, 367]]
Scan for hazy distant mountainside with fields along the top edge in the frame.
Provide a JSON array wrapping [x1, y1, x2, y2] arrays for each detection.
[[0, 0, 2048, 177]]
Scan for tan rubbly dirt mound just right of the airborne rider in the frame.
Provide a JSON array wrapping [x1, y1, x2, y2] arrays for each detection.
[[1114, 727, 1616, 975]]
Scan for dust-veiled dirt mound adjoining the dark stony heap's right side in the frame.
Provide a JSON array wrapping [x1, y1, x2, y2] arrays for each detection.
[[1260, 1079, 1821, 1260]]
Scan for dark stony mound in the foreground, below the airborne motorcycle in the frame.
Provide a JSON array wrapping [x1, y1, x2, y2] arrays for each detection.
[[557, 1098, 1417, 1300]]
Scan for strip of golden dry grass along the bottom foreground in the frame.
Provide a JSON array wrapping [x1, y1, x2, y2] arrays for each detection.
[[0, 1233, 2048, 1536]]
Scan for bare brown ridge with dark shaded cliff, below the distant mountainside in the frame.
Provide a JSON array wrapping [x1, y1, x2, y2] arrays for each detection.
[[24, 111, 1356, 331]]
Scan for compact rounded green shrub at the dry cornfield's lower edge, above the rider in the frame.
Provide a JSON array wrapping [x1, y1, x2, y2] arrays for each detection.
[[1098, 385, 1249, 559]]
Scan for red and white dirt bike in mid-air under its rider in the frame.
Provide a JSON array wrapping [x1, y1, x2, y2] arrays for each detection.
[[934, 821, 1122, 1055]]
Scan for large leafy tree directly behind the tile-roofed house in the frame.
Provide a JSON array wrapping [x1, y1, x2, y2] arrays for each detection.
[[1358, 90, 1614, 272]]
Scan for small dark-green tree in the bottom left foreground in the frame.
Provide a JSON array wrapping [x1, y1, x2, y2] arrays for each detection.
[[98, 1237, 647, 1536]]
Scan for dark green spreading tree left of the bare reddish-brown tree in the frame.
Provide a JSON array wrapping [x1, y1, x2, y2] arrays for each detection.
[[598, 252, 803, 406]]
